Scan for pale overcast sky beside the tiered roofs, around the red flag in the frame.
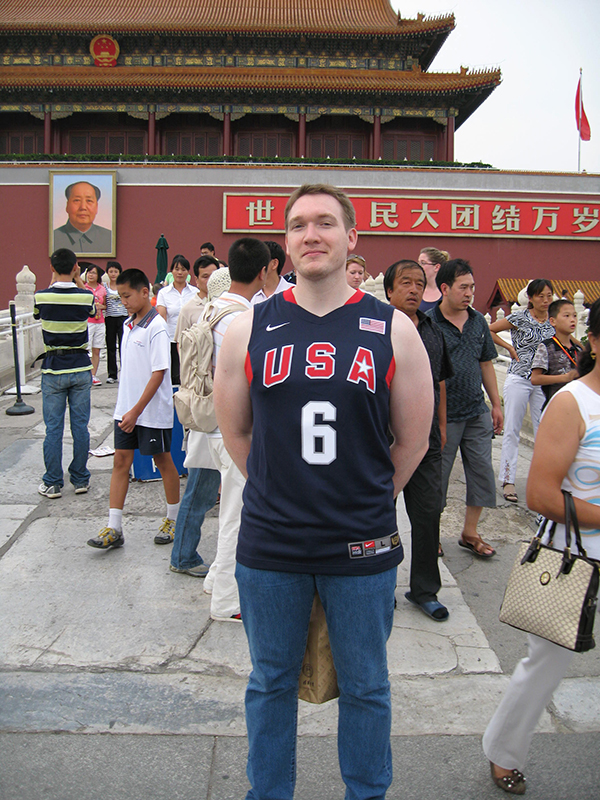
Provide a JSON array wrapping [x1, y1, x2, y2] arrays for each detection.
[[391, 0, 600, 173]]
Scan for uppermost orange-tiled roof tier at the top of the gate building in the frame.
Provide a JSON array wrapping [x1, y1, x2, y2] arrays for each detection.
[[0, 0, 454, 36]]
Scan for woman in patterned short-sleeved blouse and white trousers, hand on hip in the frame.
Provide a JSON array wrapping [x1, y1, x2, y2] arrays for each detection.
[[490, 278, 554, 503]]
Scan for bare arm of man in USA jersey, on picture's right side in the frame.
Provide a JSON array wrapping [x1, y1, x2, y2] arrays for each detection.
[[390, 311, 433, 494]]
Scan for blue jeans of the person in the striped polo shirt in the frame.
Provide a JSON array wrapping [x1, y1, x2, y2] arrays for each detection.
[[42, 370, 92, 487]]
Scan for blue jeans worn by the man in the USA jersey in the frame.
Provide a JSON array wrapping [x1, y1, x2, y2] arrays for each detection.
[[235, 563, 396, 800]]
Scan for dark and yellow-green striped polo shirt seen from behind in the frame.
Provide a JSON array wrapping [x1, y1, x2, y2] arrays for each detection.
[[33, 281, 96, 375]]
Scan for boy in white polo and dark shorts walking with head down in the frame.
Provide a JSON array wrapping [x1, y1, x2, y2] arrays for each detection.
[[88, 269, 179, 550]]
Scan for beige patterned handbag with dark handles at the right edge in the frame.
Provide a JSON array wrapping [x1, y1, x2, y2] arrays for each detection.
[[500, 490, 599, 653]]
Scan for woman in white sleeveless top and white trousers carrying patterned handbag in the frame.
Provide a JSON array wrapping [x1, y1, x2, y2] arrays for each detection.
[[483, 300, 600, 794]]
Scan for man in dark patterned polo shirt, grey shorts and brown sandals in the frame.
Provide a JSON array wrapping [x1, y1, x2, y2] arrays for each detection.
[[427, 258, 504, 558]]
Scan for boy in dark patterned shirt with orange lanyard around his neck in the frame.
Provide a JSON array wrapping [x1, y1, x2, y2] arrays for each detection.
[[531, 299, 581, 407]]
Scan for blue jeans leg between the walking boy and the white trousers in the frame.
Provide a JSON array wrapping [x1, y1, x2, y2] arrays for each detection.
[[171, 467, 221, 569]]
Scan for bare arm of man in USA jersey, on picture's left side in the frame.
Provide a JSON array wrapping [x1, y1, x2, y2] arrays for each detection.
[[214, 311, 252, 478]]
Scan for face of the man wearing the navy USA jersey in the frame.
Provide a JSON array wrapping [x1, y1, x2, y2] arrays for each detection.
[[285, 194, 358, 280]]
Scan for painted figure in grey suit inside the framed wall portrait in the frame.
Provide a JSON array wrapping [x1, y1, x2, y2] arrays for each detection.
[[54, 181, 112, 254]]
